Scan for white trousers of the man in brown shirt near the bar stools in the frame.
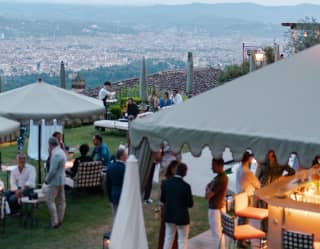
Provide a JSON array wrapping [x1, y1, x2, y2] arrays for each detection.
[[208, 209, 225, 249]]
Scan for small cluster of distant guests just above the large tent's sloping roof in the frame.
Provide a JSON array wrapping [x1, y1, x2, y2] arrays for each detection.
[[149, 89, 183, 112]]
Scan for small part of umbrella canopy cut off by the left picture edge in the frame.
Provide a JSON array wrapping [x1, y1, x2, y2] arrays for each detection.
[[0, 117, 20, 143]]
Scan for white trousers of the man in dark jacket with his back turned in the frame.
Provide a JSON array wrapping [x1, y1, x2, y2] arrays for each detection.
[[163, 223, 190, 249]]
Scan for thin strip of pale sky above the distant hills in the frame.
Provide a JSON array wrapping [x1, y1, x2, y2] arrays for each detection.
[[0, 0, 320, 5]]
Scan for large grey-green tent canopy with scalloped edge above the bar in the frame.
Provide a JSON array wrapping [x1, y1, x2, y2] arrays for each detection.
[[130, 45, 320, 166]]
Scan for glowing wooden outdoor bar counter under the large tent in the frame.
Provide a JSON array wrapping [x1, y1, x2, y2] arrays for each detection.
[[256, 170, 320, 249]]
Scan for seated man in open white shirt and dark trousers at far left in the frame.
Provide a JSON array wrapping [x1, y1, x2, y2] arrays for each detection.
[[5, 153, 36, 213]]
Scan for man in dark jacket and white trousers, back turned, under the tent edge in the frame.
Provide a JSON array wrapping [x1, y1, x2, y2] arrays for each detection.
[[160, 163, 193, 249]]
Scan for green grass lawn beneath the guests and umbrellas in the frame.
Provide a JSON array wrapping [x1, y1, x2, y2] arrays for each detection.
[[0, 126, 208, 249]]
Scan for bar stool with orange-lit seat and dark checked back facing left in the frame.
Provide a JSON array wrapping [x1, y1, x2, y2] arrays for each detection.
[[221, 212, 266, 248]]
